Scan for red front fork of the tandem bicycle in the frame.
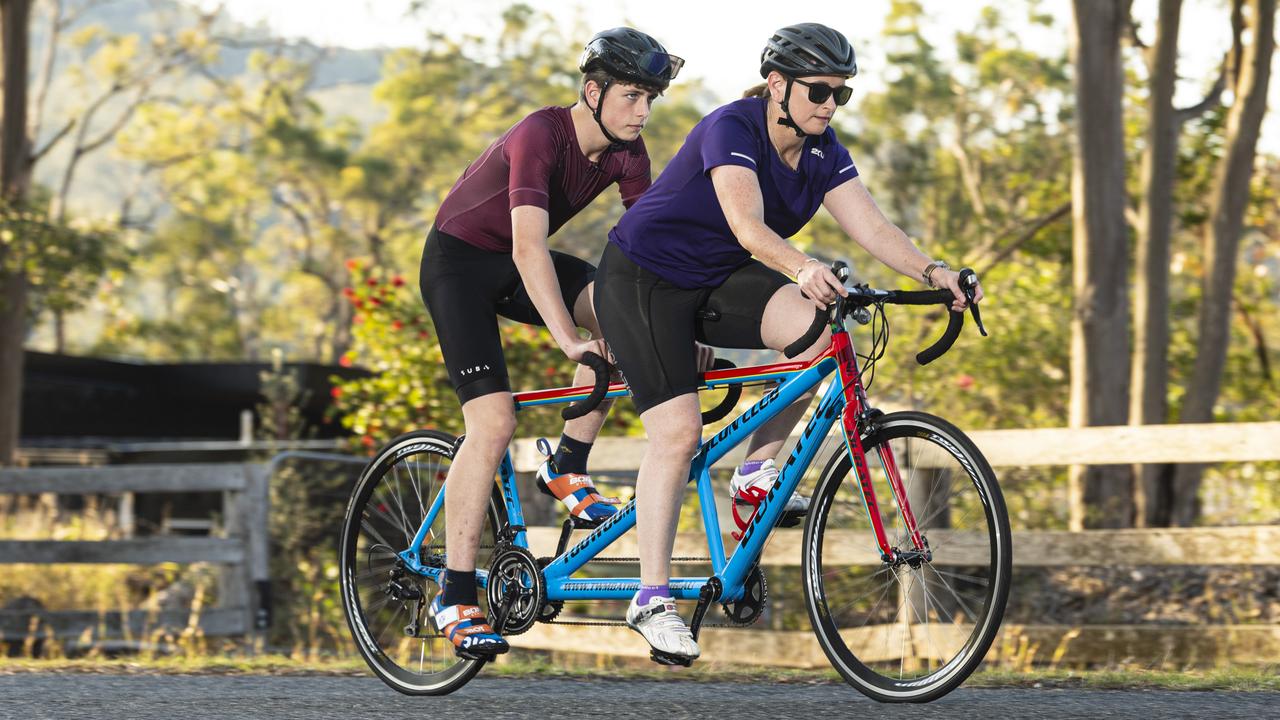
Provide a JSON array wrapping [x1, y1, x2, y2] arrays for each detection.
[[831, 332, 924, 562]]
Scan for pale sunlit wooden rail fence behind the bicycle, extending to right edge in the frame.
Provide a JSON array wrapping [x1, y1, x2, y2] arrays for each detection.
[[512, 423, 1280, 667]]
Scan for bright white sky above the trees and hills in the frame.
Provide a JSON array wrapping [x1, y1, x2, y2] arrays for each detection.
[[198, 0, 1280, 154]]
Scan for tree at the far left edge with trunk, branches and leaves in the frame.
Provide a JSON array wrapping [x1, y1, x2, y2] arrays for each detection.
[[0, 0, 212, 464]]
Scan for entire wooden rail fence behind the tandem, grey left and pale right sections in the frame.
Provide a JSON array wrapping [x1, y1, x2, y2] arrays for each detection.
[[0, 423, 1280, 667]]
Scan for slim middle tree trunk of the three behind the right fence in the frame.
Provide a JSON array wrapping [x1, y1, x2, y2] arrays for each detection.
[[1129, 0, 1183, 527]]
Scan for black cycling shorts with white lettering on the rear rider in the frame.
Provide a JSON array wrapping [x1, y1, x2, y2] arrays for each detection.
[[419, 225, 595, 404]]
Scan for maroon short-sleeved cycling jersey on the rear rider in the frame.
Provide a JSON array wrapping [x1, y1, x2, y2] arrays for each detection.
[[435, 106, 649, 252]]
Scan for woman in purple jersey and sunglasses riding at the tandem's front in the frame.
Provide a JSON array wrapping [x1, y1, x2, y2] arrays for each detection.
[[595, 23, 982, 661]]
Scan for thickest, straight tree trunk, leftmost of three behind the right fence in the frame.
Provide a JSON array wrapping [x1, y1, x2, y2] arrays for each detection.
[[1070, 0, 1133, 529]]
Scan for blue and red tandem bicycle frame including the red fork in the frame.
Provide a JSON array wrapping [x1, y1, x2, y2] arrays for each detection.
[[399, 318, 925, 602]]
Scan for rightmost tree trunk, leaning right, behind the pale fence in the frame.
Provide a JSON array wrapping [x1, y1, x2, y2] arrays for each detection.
[[1171, 0, 1276, 527]]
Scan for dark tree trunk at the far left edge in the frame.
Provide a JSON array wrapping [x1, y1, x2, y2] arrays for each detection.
[[0, 0, 31, 465]]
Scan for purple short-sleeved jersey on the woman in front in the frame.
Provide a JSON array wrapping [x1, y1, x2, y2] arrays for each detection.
[[609, 97, 858, 288]]
